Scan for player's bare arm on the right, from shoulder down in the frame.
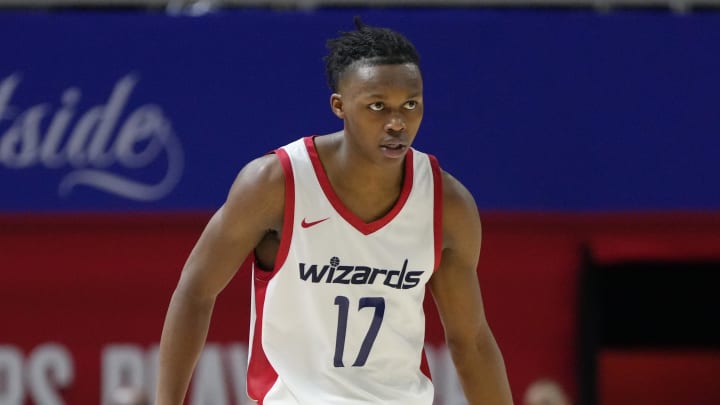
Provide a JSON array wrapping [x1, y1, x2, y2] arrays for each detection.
[[430, 173, 512, 405]]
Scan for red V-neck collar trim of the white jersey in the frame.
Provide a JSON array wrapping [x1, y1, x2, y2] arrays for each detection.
[[304, 136, 413, 235]]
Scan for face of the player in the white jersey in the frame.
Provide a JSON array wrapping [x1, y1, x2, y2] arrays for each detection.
[[331, 64, 423, 162]]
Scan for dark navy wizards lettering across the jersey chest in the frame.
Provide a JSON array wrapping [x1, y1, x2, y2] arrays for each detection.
[[298, 256, 424, 289]]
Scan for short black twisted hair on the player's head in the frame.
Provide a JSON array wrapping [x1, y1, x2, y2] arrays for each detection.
[[325, 17, 420, 91]]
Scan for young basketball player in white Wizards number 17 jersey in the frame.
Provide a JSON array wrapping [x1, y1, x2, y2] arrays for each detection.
[[157, 20, 512, 405]]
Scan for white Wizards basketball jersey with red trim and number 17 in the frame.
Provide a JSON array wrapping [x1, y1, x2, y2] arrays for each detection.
[[247, 137, 442, 405]]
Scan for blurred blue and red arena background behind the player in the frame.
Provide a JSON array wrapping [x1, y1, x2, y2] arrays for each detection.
[[0, 0, 720, 405]]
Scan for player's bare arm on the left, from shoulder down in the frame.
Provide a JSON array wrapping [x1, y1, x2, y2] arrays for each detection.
[[156, 155, 285, 405]]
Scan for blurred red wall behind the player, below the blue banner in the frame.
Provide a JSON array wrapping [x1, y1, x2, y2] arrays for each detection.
[[0, 213, 720, 404]]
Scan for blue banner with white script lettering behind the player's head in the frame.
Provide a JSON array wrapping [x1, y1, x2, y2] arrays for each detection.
[[0, 9, 720, 213]]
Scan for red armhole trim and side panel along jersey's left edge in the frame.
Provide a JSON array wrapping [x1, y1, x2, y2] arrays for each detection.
[[247, 149, 295, 404]]
